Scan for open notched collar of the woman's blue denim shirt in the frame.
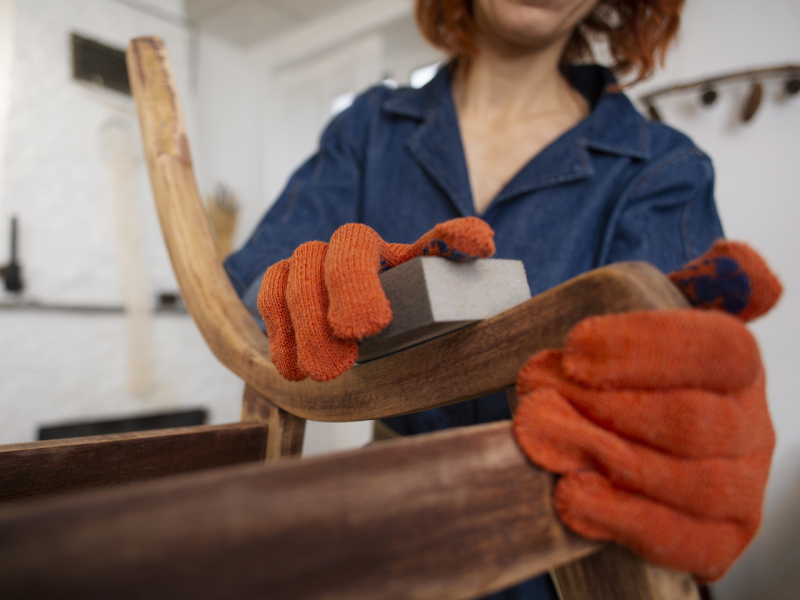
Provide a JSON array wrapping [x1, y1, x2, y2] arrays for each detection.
[[382, 65, 649, 216]]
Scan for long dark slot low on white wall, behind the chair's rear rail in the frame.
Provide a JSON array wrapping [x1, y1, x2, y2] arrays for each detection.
[[39, 409, 208, 440]]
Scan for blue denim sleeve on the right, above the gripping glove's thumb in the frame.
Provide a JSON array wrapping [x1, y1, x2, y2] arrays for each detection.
[[600, 148, 723, 273]]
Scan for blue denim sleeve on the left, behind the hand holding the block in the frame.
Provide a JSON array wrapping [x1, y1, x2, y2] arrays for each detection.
[[220, 93, 372, 297]]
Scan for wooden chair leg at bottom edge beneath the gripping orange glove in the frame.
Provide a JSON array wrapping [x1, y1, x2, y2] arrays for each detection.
[[555, 544, 700, 600]]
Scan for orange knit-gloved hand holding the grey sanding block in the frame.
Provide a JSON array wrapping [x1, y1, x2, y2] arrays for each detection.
[[258, 217, 494, 381]]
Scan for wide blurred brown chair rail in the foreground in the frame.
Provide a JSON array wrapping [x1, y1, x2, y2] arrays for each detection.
[[0, 422, 597, 600]]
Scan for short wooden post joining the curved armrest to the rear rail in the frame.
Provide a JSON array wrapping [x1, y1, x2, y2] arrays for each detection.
[[242, 385, 306, 462]]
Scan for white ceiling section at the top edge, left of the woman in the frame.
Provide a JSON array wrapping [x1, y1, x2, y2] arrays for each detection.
[[186, 0, 359, 48]]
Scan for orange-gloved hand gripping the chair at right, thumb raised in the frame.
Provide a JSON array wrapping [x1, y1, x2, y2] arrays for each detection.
[[514, 241, 781, 581]]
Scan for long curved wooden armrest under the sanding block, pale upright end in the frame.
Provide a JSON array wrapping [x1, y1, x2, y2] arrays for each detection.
[[128, 38, 686, 421]]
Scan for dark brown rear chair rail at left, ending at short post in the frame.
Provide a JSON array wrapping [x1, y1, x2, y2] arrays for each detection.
[[0, 423, 267, 501]]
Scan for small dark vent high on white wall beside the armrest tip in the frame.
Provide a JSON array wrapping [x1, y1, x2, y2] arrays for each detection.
[[72, 33, 131, 96]]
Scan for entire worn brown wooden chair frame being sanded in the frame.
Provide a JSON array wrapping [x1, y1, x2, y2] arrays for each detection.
[[0, 38, 698, 600]]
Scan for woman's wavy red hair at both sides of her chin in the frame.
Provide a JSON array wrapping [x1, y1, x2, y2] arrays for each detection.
[[416, 0, 685, 83]]
